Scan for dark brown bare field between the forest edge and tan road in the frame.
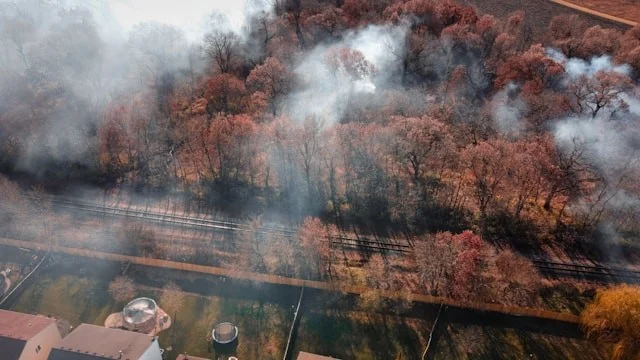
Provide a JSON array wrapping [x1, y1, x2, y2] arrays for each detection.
[[458, 0, 629, 41]]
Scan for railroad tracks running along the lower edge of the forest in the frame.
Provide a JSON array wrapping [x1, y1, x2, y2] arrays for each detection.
[[28, 198, 640, 283]]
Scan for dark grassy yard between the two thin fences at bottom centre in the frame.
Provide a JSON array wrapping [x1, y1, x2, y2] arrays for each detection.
[[296, 310, 431, 360]]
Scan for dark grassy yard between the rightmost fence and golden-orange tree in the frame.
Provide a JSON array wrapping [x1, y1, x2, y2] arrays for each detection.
[[434, 324, 608, 360]]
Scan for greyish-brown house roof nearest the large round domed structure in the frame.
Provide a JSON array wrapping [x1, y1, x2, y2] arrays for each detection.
[[49, 324, 156, 360]]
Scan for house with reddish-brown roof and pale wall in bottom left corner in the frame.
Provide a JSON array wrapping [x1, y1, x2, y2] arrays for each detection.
[[0, 310, 64, 360]]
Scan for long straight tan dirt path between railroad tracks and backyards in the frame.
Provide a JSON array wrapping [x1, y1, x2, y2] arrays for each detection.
[[0, 238, 579, 324]]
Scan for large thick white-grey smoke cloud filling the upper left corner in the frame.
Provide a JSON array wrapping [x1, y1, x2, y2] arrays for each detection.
[[0, 0, 270, 175]]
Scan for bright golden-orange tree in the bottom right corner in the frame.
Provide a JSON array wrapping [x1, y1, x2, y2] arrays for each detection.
[[580, 285, 640, 360]]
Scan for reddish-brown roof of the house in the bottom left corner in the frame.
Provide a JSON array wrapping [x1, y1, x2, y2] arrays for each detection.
[[0, 310, 56, 340]]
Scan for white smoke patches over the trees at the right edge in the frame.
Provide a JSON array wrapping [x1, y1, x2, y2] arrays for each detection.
[[548, 50, 640, 239]]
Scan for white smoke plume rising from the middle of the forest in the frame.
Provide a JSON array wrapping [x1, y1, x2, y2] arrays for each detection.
[[287, 26, 407, 124]]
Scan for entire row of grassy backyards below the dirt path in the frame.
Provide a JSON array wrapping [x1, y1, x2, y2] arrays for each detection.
[[8, 258, 606, 360]]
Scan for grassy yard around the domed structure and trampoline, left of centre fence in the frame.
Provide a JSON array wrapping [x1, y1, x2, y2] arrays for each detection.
[[8, 262, 293, 360]]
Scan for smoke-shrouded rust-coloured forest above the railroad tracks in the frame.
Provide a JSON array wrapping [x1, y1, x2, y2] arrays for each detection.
[[0, 0, 640, 262]]
